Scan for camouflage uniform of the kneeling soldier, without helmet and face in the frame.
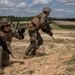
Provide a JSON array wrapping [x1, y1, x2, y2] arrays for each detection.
[[0, 18, 22, 74]]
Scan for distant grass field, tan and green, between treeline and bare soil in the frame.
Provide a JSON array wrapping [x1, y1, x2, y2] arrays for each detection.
[[13, 21, 75, 30]]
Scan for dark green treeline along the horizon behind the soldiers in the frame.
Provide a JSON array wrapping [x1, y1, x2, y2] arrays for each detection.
[[0, 16, 75, 22]]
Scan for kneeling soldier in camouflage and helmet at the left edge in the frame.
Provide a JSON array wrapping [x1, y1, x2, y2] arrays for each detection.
[[0, 18, 23, 74]]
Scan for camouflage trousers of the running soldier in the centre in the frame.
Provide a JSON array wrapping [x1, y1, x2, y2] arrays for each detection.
[[26, 30, 43, 55]]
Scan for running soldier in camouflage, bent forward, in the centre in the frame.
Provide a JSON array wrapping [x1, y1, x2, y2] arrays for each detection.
[[24, 7, 53, 59]]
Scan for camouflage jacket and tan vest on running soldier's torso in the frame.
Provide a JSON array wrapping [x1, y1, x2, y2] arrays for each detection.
[[28, 13, 48, 30]]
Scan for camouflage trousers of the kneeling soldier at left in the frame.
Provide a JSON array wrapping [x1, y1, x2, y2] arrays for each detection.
[[0, 46, 9, 67]]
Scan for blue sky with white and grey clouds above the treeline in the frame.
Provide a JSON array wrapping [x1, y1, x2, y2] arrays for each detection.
[[0, 0, 75, 18]]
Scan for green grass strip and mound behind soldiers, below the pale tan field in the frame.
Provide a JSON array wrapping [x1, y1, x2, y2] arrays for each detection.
[[12, 21, 75, 30]]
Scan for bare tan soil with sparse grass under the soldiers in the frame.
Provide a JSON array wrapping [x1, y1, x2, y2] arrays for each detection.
[[4, 30, 75, 75]]
